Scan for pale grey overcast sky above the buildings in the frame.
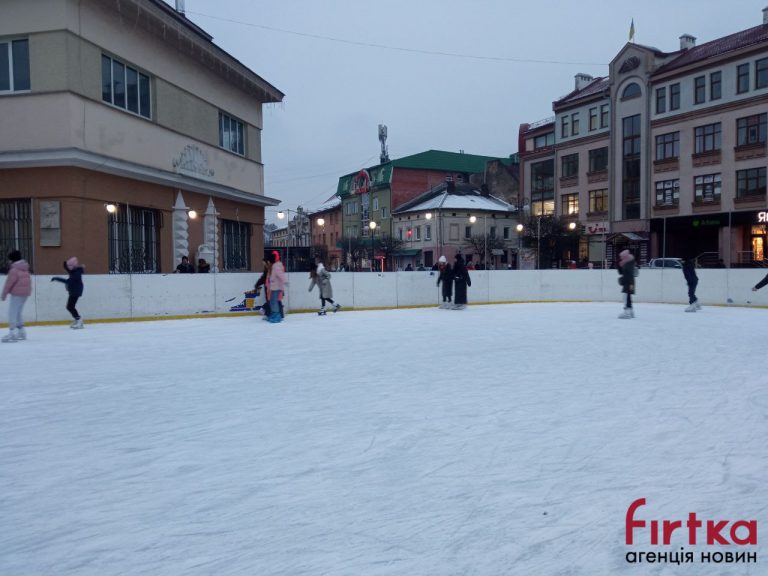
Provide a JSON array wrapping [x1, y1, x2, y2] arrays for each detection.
[[167, 0, 768, 221]]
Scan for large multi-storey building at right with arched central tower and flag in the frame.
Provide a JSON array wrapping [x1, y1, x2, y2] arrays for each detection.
[[520, 9, 768, 265]]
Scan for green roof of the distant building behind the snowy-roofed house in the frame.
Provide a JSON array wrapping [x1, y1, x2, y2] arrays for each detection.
[[336, 150, 509, 197]]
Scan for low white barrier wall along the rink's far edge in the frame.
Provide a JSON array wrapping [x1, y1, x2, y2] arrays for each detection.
[[0, 268, 768, 323]]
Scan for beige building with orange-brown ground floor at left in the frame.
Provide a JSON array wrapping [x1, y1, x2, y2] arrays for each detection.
[[0, 0, 283, 273]]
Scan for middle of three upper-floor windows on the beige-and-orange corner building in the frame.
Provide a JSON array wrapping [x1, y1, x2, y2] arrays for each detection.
[[101, 54, 152, 118]]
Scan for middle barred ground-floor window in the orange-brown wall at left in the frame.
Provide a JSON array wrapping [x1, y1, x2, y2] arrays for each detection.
[[108, 204, 161, 274]]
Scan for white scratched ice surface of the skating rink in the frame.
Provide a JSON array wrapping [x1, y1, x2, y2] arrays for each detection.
[[0, 302, 768, 576]]
